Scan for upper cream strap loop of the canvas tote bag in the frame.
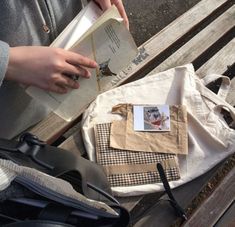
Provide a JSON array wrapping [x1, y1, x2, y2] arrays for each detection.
[[201, 74, 231, 100]]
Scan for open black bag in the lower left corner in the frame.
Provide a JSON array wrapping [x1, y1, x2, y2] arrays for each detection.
[[0, 133, 129, 227]]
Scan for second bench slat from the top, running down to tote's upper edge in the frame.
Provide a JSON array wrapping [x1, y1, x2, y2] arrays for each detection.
[[150, 5, 235, 74]]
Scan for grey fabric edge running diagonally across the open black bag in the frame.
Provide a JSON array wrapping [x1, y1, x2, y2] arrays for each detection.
[[0, 159, 118, 216]]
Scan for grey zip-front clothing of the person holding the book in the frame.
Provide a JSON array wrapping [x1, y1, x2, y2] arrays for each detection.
[[0, 0, 82, 138]]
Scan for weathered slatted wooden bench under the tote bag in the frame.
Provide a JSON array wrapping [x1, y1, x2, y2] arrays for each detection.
[[31, 0, 235, 226]]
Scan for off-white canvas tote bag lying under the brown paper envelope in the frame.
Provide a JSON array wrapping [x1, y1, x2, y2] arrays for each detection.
[[82, 64, 235, 196]]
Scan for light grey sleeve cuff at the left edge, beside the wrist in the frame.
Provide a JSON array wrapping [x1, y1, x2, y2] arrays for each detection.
[[0, 41, 9, 86]]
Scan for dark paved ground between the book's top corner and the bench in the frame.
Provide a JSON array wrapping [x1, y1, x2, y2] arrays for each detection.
[[123, 0, 200, 46]]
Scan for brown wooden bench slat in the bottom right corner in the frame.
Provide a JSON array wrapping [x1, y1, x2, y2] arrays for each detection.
[[185, 168, 235, 227]]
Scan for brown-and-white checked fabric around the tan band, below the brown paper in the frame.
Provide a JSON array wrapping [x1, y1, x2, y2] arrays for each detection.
[[95, 123, 180, 187]]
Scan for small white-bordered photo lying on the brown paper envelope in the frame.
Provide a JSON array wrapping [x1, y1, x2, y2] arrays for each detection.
[[133, 105, 170, 131]]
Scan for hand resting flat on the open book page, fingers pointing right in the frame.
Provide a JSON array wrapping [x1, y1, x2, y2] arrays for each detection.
[[5, 46, 97, 93]]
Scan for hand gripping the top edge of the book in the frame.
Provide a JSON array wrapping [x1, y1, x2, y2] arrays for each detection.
[[94, 0, 129, 29]]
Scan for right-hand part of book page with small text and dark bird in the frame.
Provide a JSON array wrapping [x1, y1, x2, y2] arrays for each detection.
[[92, 19, 137, 92]]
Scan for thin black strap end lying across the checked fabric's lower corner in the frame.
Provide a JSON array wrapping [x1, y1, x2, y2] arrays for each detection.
[[157, 163, 187, 220]]
